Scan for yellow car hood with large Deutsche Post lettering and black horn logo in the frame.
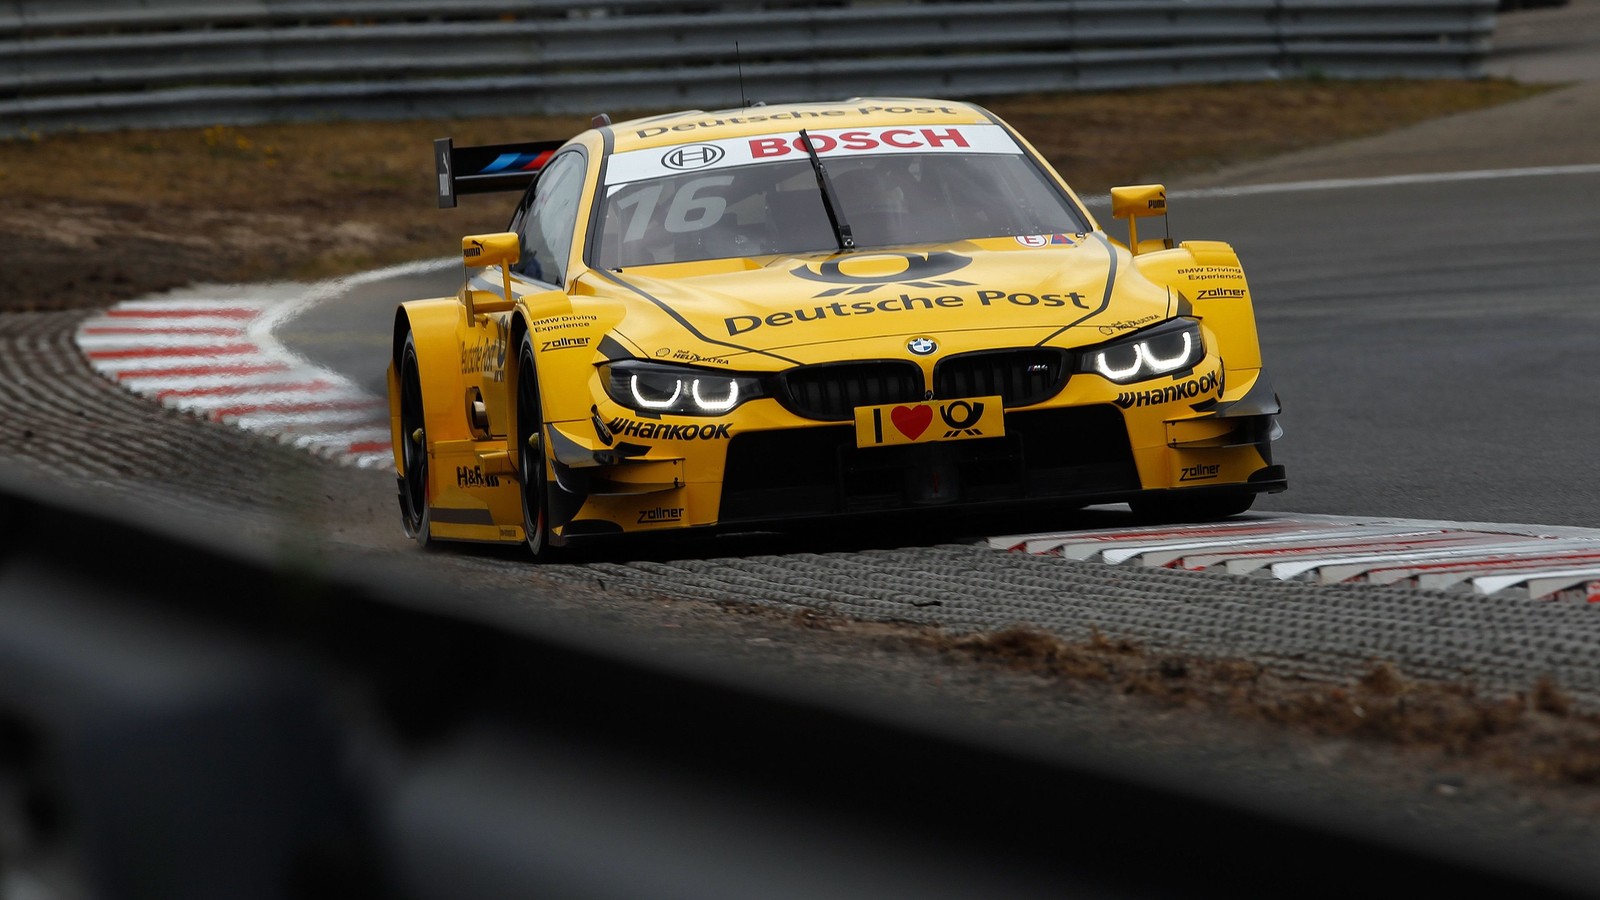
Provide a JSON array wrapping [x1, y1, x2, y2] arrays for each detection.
[[590, 234, 1176, 365]]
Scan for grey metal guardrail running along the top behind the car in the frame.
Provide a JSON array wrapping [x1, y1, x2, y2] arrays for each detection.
[[0, 0, 1496, 136]]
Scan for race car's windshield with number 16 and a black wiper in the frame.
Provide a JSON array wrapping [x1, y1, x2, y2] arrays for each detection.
[[595, 127, 1088, 269]]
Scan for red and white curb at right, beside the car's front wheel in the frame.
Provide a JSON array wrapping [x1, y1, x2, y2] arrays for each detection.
[[989, 514, 1600, 602]]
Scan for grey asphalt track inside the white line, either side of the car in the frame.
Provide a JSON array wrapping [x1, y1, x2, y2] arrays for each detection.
[[277, 154, 1600, 525]]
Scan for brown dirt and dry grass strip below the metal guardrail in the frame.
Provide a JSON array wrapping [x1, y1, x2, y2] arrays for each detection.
[[0, 80, 1541, 311]]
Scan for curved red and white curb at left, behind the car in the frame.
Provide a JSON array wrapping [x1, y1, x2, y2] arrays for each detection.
[[75, 261, 440, 469]]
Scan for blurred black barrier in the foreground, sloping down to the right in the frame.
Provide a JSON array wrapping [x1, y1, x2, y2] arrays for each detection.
[[0, 469, 1587, 900]]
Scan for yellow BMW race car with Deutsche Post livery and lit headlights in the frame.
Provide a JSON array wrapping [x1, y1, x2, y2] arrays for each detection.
[[389, 98, 1286, 557]]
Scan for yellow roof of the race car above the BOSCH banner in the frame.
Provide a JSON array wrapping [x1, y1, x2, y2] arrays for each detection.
[[610, 98, 995, 152]]
